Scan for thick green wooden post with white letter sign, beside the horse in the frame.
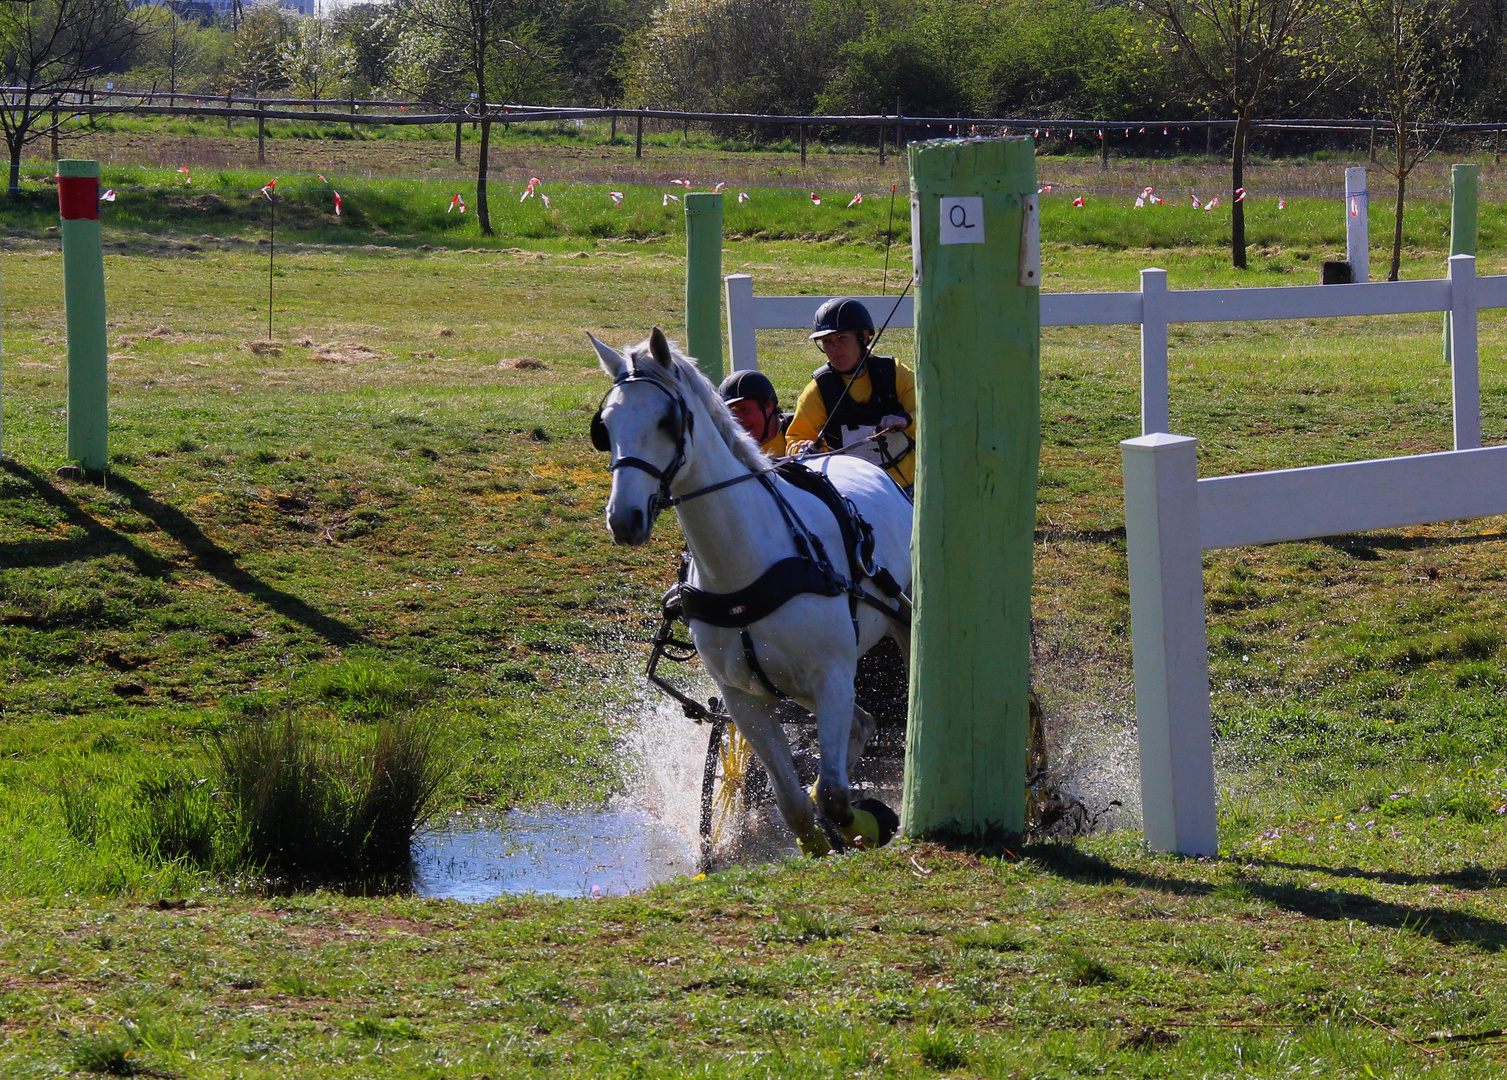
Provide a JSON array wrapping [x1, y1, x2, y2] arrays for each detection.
[[901, 137, 1041, 839]]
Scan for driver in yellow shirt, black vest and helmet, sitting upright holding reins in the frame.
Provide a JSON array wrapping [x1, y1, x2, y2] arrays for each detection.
[[785, 297, 916, 494]]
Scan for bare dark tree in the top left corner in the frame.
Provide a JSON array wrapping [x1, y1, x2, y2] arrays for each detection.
[[0, 0, 145, 197]]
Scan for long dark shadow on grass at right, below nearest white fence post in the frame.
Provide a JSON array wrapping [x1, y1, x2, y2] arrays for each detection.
[[1020, 844, 1507, 952]]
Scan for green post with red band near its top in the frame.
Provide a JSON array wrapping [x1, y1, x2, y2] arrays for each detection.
[[57, 160, 110, 471]]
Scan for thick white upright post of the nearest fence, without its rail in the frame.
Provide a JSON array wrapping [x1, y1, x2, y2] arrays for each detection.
[[1120, 432, 1219, 856]]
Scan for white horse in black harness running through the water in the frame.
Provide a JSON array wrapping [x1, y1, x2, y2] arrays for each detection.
[[591, 327, 912, 854]]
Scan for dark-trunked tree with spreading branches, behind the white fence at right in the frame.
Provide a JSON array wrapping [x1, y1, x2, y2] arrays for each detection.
[[1144, 0, 1334, 270]]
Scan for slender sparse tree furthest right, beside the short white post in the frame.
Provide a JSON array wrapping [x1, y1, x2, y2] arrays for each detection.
[[1353, 0, 1471, 282]]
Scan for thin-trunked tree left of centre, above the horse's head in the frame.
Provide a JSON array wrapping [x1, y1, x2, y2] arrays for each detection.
[[393, 0, 559, 236]]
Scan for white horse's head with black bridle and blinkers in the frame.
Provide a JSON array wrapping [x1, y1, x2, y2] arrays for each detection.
[[588, 327, 696, 544]]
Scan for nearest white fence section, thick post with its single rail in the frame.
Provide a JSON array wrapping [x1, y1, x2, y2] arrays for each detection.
[[1120, 433, 1507, 856]]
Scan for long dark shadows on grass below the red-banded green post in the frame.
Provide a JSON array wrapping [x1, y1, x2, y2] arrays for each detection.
[[0, 461, 366, 645]]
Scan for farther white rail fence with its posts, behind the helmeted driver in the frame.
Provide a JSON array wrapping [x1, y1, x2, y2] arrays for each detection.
[[725, 255, 1507, 450]]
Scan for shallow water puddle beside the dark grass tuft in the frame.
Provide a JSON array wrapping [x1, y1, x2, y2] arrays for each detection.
[[413, 809, 696, 904]]
